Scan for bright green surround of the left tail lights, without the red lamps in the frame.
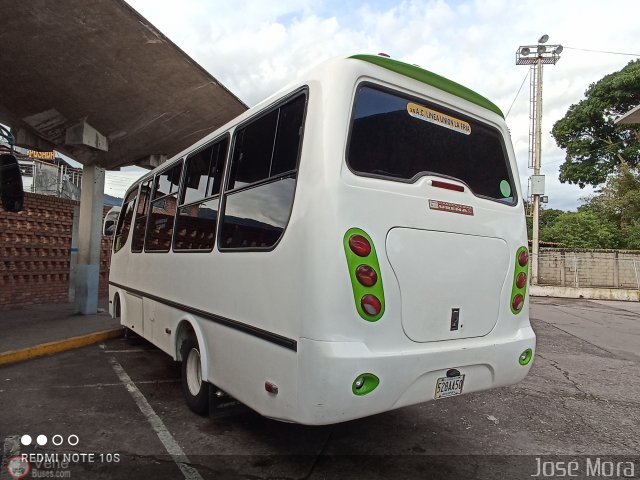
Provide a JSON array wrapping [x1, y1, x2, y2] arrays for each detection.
[[343, 228, 384, 322]]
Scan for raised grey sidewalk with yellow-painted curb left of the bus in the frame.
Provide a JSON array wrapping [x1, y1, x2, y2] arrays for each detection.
[[0, 298, 122, 365]]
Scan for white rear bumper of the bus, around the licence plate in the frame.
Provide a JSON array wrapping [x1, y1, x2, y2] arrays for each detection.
[[296, 326, 536, 425]]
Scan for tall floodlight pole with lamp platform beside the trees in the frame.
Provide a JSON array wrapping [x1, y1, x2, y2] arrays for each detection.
[[516, 35, 562, 285]]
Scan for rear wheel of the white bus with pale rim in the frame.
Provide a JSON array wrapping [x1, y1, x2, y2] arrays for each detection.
[[180, 336, 209, 415]]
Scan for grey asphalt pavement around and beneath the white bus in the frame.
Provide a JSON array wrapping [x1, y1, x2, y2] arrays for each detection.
[[0, 298, 640, 480]]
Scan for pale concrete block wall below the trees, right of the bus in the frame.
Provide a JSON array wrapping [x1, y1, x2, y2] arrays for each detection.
[[538, 248, 640, 289]]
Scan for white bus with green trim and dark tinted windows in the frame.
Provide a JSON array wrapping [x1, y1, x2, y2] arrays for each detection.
[[109, 55, 535, 424]]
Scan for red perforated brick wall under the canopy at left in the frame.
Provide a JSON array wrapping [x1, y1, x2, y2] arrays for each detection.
[[0, 193, 112, 310]]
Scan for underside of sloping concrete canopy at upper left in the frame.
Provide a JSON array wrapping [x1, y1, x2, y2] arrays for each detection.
[[0, 0, 247, 169]]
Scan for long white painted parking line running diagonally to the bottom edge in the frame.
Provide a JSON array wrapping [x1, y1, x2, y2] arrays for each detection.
[[109, 357, 204, 480]]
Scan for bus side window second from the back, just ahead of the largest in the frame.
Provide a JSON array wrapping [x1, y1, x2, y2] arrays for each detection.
[[173, 137, 229, 251]]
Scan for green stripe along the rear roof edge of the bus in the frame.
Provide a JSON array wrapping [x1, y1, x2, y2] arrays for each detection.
[[349, 55, 504, 118]]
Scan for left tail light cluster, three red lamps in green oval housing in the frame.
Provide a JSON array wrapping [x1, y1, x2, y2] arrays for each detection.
[[343, 228, 384, 322]]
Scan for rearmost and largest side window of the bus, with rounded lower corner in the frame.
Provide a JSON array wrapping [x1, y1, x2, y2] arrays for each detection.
[[219, 91, 306, 249]]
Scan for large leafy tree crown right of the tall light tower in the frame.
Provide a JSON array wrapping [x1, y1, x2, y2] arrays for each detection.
[[551, 60, 640, 188]]
